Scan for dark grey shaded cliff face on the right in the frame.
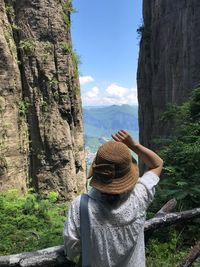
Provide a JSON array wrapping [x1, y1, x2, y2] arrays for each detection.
[[137, 0, 200, 151]]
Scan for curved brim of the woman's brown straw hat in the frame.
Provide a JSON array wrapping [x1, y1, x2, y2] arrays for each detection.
[[88, 163, 139, 194]]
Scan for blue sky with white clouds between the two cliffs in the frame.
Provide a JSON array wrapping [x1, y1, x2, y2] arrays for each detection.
[[71, 0, 142, 106]]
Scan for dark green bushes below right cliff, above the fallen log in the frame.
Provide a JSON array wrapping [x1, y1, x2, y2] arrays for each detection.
[[152, 88, 200, 209]]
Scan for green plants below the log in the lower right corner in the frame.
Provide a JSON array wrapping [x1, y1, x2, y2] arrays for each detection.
[[146, 224, 200, 267]]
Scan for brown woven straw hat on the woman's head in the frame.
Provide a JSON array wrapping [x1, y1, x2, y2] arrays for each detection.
[[88, 141, 139, 194]]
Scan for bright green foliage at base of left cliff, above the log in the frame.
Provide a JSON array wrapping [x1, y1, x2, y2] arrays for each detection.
[[0, 190, 67, 255]]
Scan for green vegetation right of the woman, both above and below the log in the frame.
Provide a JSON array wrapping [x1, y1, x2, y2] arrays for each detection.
[[147, 88, 200, 267]]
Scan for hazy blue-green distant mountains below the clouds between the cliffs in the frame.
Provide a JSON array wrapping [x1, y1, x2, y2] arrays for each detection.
[[83, 105, 138, 138]]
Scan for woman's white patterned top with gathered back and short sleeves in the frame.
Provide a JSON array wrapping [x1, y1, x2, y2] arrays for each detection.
[[64, 171, 159, 267]]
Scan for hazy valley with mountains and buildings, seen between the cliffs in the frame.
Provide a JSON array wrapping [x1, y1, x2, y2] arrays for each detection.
[[83, 105, 138, 166]]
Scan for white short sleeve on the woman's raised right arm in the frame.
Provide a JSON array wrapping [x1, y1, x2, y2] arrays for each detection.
[[134, 171, 160, 208]]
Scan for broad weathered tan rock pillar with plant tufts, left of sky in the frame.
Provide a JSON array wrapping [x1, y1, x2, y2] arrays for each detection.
[[0, 0, 85, 199]]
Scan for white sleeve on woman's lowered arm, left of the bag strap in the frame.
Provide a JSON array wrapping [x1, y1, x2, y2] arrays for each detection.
[[63, 197, 81, 258]]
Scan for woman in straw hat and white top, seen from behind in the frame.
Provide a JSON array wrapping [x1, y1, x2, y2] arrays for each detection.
[[64, 130, 163, 267]]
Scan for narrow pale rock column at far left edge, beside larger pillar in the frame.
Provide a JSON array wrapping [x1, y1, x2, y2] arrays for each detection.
[[0, 1, 28, 195]]
